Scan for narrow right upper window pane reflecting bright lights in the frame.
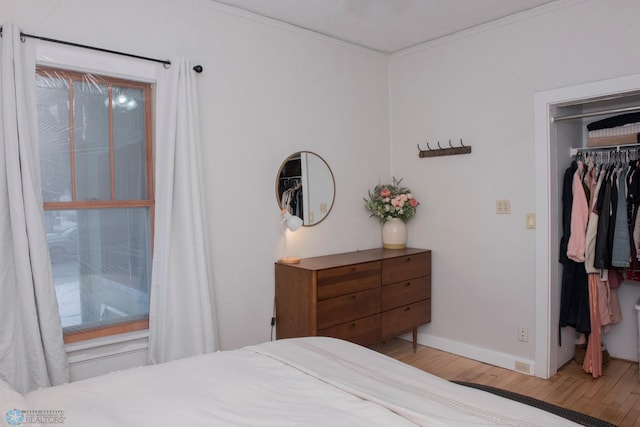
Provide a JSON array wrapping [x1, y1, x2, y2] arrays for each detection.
[[112, 87, 147, 200]]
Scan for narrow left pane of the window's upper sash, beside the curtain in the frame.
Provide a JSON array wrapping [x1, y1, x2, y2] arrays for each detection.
[[36, 74, 71, 202]]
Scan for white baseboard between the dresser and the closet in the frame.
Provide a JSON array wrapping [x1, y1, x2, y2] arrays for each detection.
[[407, 332, 535, 375]]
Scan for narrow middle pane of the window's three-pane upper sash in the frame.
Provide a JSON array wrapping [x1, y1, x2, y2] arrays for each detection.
[[73, 79, 111, 200]]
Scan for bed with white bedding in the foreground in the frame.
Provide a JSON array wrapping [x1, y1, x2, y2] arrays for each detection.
[[0, 337, 578, 427]]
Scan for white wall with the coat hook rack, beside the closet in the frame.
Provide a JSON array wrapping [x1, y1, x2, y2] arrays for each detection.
[[390, 0, 640, 374]]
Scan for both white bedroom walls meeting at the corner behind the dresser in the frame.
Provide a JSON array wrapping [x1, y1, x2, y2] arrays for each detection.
[[5, 0, 640, 382]]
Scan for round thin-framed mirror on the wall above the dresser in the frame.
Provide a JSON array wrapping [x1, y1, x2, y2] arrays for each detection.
[[276, 151, 336, 227]]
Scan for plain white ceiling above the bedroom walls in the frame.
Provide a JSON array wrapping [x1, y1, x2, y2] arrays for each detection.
[[212, 0, 556, 53]]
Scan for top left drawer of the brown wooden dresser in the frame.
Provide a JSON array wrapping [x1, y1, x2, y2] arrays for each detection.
[[318, 261, 380, 300]]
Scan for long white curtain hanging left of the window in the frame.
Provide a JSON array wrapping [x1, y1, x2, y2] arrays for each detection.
[[0, 24, 69, 393]]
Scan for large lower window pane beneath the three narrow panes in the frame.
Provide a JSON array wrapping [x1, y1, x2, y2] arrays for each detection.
[[47, 208, 151, 332]]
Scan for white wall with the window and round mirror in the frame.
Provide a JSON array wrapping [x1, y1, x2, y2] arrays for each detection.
[[0, 0, 390, 360]]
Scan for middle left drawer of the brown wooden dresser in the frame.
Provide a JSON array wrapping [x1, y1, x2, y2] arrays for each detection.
[[317, 287, 380, 330]]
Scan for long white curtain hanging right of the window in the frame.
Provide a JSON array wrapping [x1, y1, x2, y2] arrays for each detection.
[[149, 59, 218, 363]]
